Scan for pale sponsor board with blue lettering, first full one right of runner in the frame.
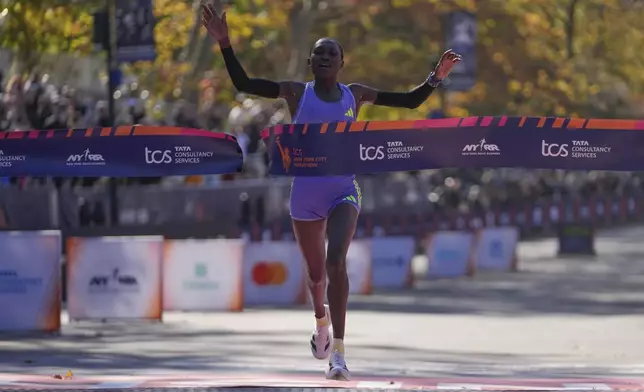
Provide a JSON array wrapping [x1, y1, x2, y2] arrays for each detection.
[[371, 237, 416, 289]]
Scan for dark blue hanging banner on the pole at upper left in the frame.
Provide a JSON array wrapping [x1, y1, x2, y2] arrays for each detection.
[[116, 0, 156, 63]]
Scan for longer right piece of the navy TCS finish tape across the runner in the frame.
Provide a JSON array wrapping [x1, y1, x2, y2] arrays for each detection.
[[262, 116, 644, 176]]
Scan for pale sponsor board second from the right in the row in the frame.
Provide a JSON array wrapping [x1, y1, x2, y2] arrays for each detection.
[[427, 231, 473, 278]]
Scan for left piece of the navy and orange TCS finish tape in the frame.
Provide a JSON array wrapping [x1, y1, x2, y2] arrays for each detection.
[[0, 126, 243, 177]]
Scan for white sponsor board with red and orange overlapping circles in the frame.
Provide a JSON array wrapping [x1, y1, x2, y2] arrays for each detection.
[[244, 241, 307, 305]]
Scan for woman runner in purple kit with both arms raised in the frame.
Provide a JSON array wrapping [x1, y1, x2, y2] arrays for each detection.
[[202, 0, 461, 380]]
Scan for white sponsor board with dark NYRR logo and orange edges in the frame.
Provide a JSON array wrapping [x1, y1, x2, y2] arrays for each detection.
[[67, 237, 163, 319]]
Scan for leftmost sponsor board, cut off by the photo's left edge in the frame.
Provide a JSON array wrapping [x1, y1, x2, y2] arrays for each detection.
[[0, 231, 62, 332]]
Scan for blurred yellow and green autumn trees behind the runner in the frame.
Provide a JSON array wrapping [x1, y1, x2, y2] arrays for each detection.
[[0, 0, 644, 120]]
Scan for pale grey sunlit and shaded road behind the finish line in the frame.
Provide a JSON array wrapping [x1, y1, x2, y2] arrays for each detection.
[[0, 228, 644, 388]]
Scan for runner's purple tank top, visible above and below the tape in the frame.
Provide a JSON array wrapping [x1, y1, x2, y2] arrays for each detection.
[[293, 82, 358, 185]]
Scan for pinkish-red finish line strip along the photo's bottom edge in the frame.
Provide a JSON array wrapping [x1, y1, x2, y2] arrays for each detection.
[[0, 373, 644, 391]]
